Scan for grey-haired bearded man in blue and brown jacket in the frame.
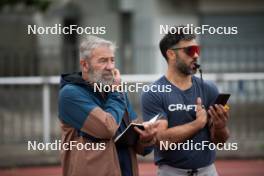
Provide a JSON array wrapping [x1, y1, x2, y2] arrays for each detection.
[[59, 36, 155, 176]]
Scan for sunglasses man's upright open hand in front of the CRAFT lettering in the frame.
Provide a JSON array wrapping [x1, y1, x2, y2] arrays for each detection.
[[196, 97, 207, 128]]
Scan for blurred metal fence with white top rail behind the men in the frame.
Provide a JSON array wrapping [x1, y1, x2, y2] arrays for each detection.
[[0, 73, 264, 166]]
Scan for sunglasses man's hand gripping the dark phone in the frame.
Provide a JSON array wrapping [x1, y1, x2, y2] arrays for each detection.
[[208, 104, 229, 129]]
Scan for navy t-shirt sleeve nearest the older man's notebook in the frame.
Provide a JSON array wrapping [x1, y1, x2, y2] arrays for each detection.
[[141, 91, 167, 121]]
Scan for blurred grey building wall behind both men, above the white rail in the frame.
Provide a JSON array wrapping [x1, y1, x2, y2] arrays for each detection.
[[0, 0, 264, 76]]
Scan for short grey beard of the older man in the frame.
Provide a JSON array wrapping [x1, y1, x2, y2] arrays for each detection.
[[88, 67, 114, 86]]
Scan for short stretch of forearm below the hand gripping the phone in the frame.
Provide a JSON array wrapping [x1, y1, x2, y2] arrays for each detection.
[[210, 126, 229, 144]]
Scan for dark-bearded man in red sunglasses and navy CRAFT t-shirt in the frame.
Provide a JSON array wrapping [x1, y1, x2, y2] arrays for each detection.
[[141, 26, 229, 176]]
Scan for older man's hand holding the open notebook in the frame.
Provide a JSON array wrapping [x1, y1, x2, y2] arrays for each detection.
[[134, 122, 158, 147]]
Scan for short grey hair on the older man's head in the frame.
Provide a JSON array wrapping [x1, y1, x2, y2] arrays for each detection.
[[79, 35, 116, 59]]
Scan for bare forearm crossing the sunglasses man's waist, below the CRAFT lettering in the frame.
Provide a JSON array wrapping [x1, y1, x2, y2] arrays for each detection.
[[157, 120, 202, 143]]
